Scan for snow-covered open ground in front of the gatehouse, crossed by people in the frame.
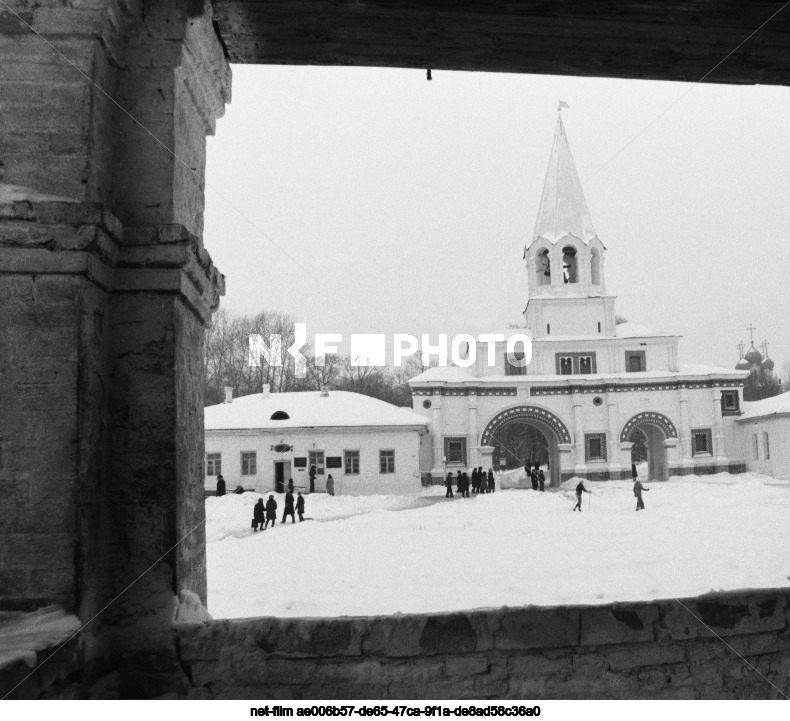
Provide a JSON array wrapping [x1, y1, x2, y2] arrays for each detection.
[[206, 474, 790, 618]]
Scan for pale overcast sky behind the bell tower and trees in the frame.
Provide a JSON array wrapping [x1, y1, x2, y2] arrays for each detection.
[[205, 65, 790, 370]]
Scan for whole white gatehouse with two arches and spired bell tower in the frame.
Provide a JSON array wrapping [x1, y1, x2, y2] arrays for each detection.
[[409, 112, 748, 485]]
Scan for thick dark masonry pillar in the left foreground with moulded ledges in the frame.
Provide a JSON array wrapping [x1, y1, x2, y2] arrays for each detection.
[[0, 0, 230, 695]]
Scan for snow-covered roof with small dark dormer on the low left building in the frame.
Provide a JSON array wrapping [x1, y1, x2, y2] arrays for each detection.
[[204, 391, 428, 431]]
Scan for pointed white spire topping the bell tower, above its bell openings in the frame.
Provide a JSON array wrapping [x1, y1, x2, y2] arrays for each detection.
[[532, 110, 595, 243]]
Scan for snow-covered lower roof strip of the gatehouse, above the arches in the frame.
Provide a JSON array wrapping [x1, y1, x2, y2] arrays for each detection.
[[409, 363, 748, 385]]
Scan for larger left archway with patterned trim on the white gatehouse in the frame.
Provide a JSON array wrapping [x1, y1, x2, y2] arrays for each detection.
[[480, 405, 571, 486]]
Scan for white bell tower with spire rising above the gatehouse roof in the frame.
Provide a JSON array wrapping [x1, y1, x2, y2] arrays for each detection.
[[524, 108, 615, 338]]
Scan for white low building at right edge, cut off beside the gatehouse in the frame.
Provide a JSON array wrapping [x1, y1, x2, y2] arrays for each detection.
[[736, 392, 790, 480]]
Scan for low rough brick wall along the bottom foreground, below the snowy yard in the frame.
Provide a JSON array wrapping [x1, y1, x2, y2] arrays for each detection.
[[176, 589, 790, 699]]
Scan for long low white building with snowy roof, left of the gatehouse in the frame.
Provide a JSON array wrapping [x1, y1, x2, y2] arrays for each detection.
[[204, 388, 430, 495]]
